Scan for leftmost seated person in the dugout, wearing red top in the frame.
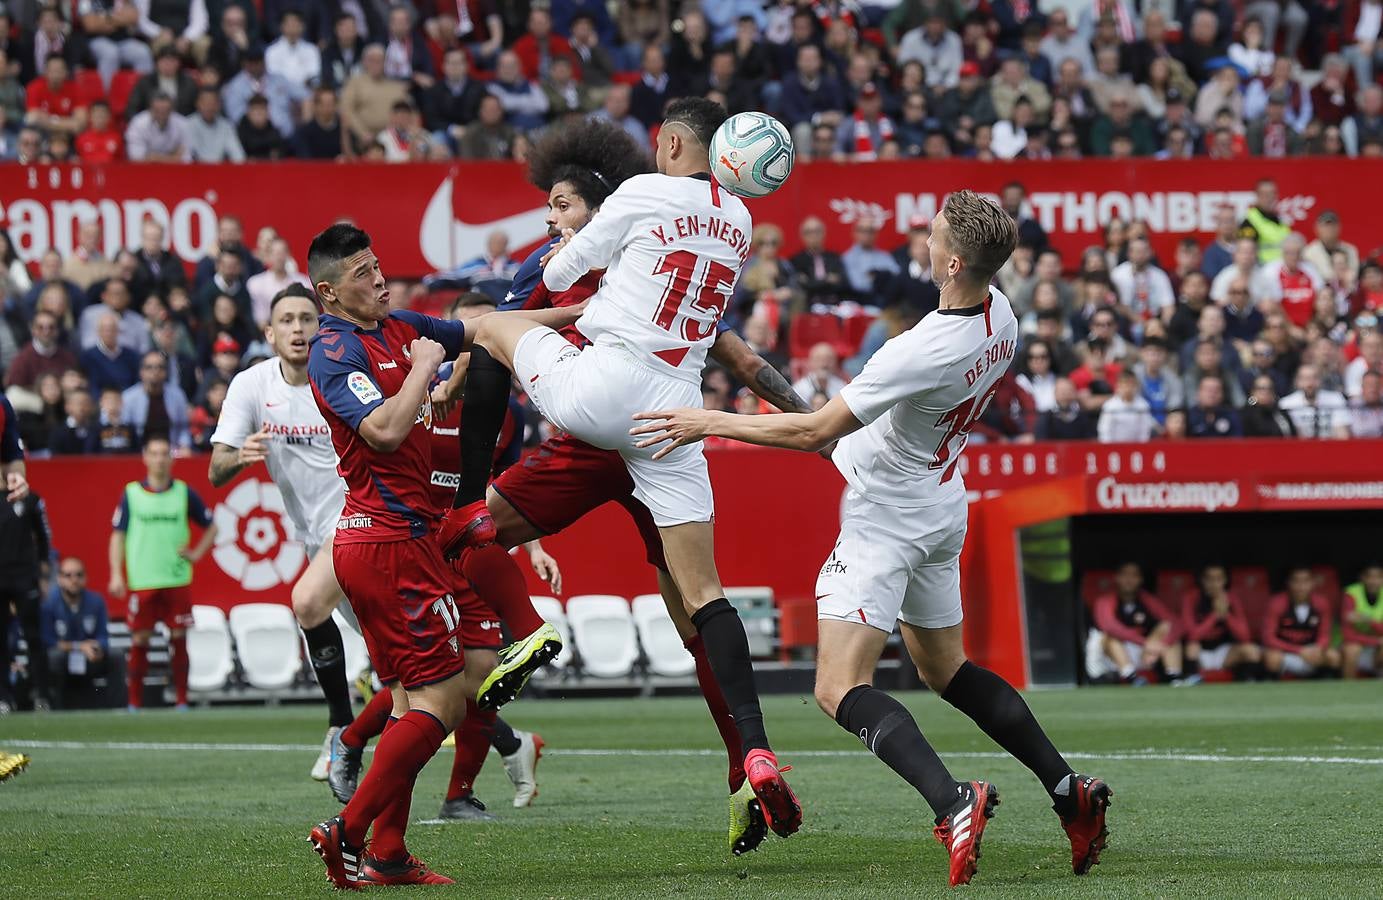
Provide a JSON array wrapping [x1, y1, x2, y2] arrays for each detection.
[[1088, 563, 1181, 684]]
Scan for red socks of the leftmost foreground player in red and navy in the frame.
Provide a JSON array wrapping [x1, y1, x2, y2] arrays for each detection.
[[342, 709, 447, 859]]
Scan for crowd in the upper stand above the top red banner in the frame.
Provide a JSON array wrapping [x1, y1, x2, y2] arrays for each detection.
[[0, 0, 1383, 162]]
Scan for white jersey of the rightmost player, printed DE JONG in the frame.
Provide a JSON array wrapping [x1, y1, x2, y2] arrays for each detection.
[[831, 288, 1018, 507]]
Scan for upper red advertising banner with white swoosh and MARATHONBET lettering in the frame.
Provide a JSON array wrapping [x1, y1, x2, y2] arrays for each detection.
[[0, 159, 1366, 276]]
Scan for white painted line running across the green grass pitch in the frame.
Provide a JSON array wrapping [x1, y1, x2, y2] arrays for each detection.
[[10, 741, 1383, 766]]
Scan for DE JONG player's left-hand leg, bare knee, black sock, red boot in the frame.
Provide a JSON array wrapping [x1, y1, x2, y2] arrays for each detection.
[[816, 618, 999, 886]]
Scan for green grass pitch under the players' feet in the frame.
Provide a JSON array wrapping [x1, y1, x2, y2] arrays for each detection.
[[0, 682, 1383, 900]]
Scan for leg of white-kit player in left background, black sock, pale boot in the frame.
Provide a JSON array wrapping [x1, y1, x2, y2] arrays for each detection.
[[292, 543, 354, 779]]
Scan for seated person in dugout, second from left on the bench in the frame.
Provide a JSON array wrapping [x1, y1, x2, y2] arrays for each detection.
[[1181, 564, 1263, 682]]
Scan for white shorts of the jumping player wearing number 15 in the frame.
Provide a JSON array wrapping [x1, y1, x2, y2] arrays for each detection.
[[514, 328, 715, 527]]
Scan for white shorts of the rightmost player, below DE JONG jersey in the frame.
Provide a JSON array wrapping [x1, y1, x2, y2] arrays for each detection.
[[816, 489, 969, 632]]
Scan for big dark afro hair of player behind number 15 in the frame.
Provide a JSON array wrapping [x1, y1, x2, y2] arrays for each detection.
[[528, 119, 653, 209]]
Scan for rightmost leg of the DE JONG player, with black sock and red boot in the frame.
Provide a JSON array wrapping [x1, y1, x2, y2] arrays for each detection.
[[903, 624, 1113, 875]]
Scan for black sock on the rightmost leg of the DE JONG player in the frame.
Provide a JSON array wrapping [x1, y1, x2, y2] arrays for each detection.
[[942, 659, 1073, 794]]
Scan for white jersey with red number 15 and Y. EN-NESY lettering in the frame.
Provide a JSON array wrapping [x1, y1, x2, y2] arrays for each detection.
[[542, 174, 754, 382]]
